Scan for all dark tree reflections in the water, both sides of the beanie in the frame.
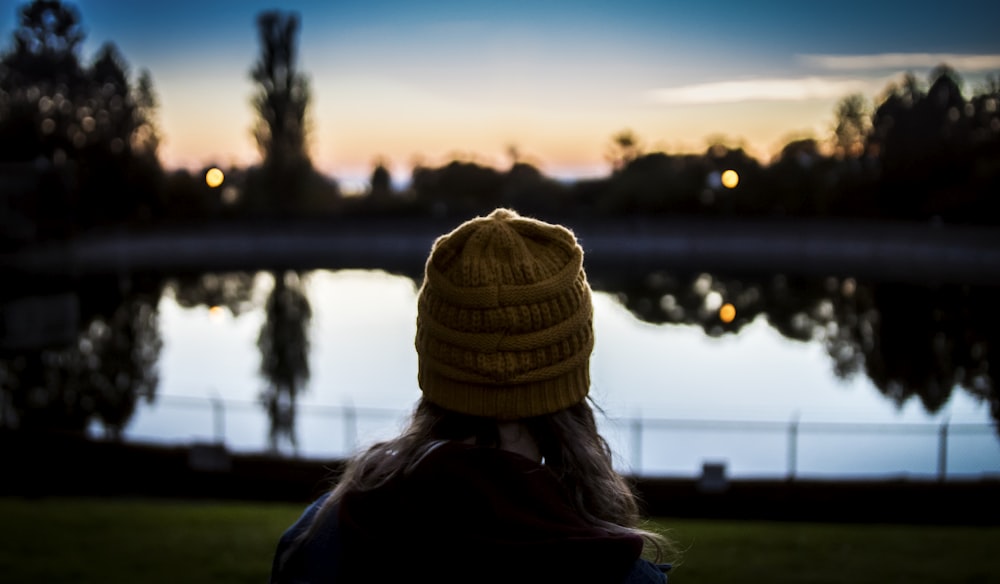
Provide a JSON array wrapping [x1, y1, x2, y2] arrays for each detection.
[[0, 270, 1000, 444]]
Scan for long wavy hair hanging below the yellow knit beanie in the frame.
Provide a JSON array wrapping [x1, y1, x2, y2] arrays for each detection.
[[303, 399, 674, 561]]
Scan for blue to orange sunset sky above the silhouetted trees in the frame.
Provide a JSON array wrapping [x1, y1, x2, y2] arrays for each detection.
[[0, 0, 1000, 190]]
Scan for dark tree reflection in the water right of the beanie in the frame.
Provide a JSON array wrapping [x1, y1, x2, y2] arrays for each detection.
[[591, 272, 1000, 438]]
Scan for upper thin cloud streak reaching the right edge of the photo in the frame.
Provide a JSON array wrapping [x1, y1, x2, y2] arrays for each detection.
[[798, 53, 1000, 72]]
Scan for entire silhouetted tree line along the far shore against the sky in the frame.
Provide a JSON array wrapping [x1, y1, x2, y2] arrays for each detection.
[[0, 0, 1000, 243]]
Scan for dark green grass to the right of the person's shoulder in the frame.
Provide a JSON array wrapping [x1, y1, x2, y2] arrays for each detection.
[[659, 520, 1000, 584]]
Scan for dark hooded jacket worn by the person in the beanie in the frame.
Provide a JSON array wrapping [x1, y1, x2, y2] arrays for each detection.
[[271, 442, 667, 584]]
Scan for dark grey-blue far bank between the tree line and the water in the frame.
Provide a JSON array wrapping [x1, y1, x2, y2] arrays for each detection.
[[7, 217, 1000, 285]]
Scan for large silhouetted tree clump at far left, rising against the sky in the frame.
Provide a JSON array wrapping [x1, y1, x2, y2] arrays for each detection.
[[0, 0, 161, 235]]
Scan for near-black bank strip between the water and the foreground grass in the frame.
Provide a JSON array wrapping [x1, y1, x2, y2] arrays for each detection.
[[0, 431, 1000, 525]]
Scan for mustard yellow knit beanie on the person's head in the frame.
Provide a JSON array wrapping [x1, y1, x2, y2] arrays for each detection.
[[415, 209, 594, 420]]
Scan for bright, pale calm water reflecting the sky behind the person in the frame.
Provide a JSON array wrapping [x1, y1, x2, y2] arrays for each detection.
[[126, 270, 1000, 478]]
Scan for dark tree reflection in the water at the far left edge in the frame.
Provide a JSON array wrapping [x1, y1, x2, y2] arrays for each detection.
[[0, 276, 163, 440]]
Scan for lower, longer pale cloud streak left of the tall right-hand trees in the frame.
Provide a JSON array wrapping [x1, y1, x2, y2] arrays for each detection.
[[646, 77, 870, 105]]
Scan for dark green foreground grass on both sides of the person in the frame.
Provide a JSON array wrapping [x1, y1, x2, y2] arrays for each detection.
[[0, 497, 1000, 584]]
